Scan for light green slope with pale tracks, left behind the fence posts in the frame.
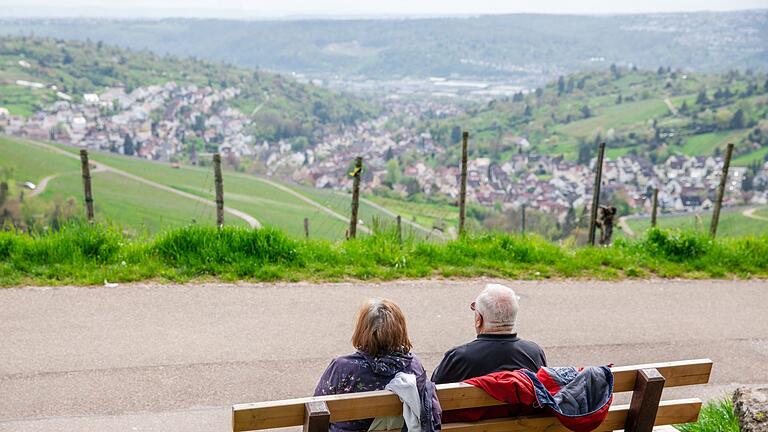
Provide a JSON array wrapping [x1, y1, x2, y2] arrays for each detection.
[[0, 136, 420, 239]]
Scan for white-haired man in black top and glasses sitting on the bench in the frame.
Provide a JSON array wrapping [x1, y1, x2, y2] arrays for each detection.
[[432, 284, 547, 384]]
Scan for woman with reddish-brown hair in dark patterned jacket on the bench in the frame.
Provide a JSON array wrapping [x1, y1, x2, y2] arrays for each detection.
[[315, 299, 441, 432]]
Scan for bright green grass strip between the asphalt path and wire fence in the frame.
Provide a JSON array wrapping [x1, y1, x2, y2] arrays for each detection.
[[0, 224, 768, 286]]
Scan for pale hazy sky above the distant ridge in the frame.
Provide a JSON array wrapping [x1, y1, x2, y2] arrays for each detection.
[[0, 0, 768, 18]]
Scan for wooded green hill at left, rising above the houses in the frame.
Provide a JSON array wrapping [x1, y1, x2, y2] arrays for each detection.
[[0, 37, 373, 141]]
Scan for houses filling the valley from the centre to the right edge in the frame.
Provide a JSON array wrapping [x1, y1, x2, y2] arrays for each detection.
[[243, 98, 768, 222]]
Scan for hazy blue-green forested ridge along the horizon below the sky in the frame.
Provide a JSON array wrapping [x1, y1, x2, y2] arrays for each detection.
[[0, 9, 768, 85]]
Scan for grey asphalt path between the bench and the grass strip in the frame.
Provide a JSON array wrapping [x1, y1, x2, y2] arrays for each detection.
[[0, 279, 768, 432]]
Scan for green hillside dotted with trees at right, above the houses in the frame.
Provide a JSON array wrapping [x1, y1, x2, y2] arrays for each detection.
[[423, 66, 768, 165]]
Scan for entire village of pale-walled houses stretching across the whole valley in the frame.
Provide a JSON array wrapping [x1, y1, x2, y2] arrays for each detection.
[[0, 82, 768, 221]]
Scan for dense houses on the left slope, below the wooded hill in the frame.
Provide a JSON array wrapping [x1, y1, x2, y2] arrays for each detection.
[[0, 82, 254, 160]]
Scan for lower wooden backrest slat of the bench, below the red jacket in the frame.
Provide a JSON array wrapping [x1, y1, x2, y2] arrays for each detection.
[[443, 399, 701, 432]]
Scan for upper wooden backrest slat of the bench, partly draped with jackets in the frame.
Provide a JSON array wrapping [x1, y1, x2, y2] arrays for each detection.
[[232, 359, 712, 432]]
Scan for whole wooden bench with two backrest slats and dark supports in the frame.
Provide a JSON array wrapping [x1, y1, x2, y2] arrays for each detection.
[[232, 359, 712, 432]]
